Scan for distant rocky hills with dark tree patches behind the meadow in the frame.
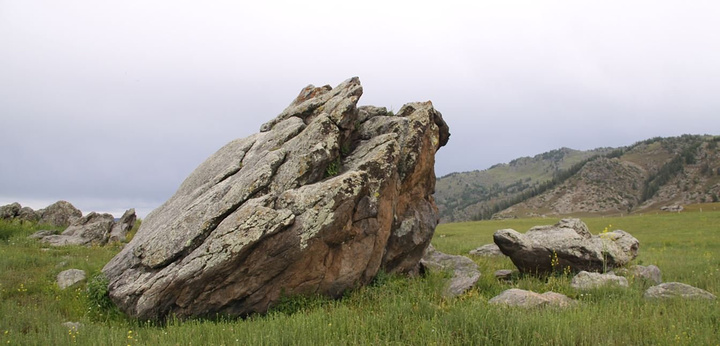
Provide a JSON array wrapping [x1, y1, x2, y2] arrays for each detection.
[[435, 135, 720, 222]]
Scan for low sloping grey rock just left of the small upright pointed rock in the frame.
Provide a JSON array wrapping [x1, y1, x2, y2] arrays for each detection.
[[41, 212, 115, 246]]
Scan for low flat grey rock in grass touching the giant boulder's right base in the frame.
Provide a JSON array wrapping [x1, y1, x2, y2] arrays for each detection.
[[420, 245, 480, 297]]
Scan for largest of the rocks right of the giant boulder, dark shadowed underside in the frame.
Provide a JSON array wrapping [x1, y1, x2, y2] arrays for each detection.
[[493, 219, 640, 274]]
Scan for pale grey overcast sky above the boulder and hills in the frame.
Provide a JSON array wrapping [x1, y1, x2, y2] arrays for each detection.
[[0, 0, 720, 217]]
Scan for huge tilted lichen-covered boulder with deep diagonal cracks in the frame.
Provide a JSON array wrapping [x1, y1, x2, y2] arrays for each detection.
[[103, 78, 449, 319]]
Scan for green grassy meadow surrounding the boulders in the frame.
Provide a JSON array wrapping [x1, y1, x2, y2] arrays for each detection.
[[0, 204, 720, 345]]
